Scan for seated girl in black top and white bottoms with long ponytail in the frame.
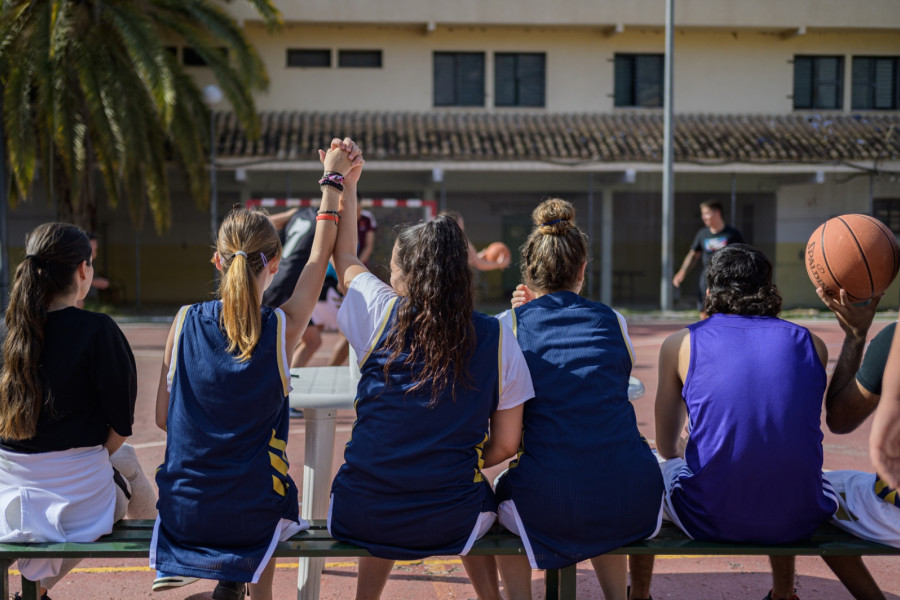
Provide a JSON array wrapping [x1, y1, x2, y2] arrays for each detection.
[[0, 223, 156, 598]]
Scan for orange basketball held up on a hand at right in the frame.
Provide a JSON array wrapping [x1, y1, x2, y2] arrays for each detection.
[[806, 215, 900, 302]]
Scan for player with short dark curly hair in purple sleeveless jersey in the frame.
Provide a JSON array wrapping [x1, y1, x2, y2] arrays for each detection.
[[631, 244, 837, 600]]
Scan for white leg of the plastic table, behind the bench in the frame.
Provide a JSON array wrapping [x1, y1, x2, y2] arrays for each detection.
[[297, 408, 337, 600]]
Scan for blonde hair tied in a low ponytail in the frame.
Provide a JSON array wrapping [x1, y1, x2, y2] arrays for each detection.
[[216, 208, 281, 362]]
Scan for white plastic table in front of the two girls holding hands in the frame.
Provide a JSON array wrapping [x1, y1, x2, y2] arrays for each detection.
[[290, 364, 359, 600]]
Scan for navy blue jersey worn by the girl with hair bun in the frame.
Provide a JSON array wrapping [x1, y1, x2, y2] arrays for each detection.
[[497, 292, 663, 569]]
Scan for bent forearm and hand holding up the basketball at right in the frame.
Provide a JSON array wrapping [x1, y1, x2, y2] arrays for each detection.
[[816, 288, 881, 433]]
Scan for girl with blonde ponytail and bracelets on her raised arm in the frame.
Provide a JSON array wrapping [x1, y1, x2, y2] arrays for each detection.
[[150, 138, 363, 600]]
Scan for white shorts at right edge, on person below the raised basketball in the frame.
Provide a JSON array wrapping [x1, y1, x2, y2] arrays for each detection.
[[823, 471, 900, 548]]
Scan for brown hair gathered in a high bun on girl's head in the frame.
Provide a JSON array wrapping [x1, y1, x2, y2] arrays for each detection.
[[520, 198, 587, 293]]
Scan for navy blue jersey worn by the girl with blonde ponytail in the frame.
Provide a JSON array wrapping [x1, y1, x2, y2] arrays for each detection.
[[155, 301, 299, 581]]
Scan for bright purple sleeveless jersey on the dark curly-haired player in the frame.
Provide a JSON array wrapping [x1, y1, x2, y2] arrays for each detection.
[[671, 314, 837, 544]]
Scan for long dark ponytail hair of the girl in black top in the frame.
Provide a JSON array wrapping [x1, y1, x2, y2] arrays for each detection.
[[0, 223, 91, 440]]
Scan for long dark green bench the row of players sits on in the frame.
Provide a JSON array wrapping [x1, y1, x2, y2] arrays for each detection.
[[0, 520, 900, 600]]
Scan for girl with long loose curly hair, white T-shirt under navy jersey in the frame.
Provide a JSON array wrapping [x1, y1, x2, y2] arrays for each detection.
[[328, 154, 534, 600]]
